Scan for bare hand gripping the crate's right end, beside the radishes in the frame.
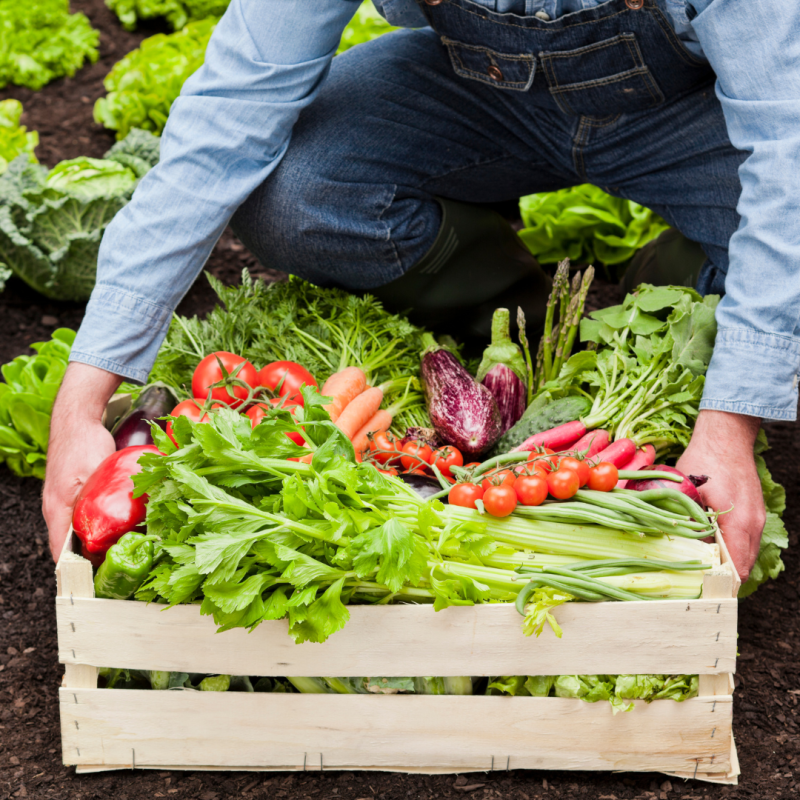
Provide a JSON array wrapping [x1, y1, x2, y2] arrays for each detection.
[[677, 410, 767, 582]]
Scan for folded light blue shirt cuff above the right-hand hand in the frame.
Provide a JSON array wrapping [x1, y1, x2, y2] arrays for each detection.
[[700, 328, 800, 422]]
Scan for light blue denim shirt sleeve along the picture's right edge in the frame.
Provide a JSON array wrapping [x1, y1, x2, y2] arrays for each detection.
[[691, 0, 800, 420]]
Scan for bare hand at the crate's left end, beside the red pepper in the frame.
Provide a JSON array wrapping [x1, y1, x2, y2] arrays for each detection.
[[42, 363, 122, 561]]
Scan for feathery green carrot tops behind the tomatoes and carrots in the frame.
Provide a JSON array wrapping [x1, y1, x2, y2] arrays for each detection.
[[150, 270, 430, 431]]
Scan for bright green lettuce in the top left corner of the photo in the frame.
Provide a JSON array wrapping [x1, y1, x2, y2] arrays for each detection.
[[0, 0, 100, 90]]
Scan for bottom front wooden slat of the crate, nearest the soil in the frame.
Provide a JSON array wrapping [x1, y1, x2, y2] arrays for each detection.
[[59, 689, 731, 775]]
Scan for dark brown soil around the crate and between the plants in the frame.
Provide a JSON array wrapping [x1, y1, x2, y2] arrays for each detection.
[[0, 0, 800, 800]]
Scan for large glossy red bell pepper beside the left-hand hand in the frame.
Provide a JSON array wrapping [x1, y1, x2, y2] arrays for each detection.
[[72, 444, 160, 563]]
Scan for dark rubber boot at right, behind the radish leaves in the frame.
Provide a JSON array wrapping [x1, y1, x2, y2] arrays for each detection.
[[620, 228, 706, 294]]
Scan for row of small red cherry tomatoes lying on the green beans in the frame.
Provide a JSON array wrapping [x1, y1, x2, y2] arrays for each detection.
[[448, 448, 619, 517]]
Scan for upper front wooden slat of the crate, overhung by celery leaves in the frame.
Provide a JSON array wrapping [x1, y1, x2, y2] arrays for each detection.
[[56, 597, 736, 676]]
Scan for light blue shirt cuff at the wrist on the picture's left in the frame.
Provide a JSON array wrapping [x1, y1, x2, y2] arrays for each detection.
[[69, 284, 172, 383]]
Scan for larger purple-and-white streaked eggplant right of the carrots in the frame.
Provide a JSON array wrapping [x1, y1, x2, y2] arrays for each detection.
[[421, 336, 503, 457]]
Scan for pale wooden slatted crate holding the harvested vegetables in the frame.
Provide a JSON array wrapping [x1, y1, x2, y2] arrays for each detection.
[[56, 396, 739, 783]]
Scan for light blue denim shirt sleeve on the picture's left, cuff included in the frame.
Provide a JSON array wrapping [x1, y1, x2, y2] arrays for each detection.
[[70, 0, 359, 383]]
